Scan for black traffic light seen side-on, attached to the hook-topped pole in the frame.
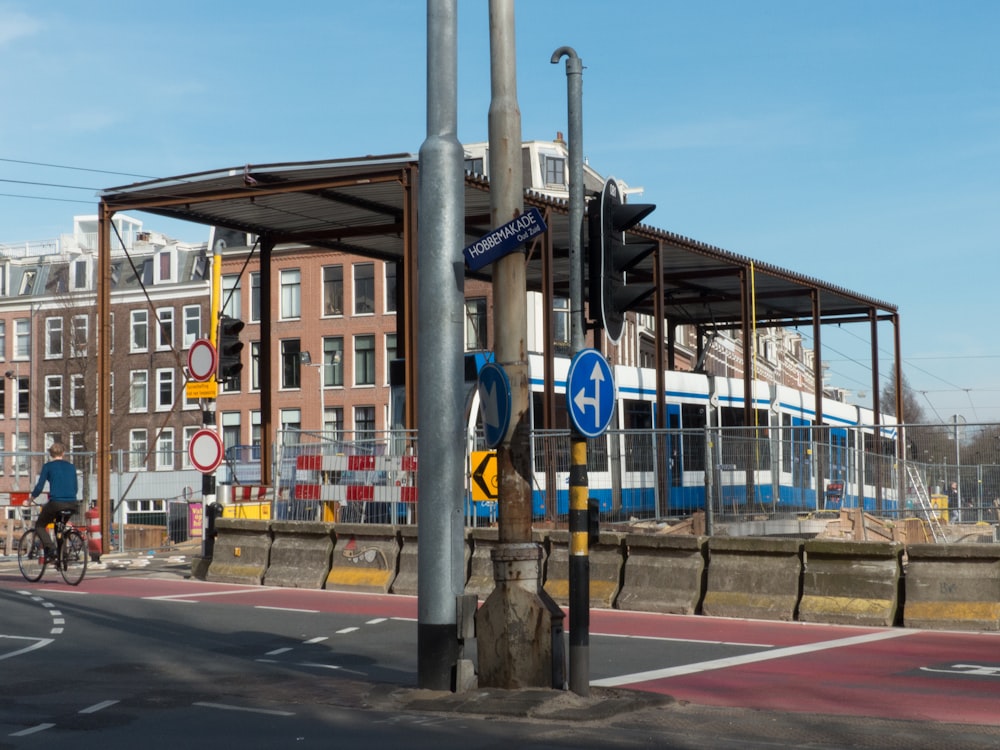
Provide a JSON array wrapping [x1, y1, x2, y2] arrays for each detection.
[[587, 177, 656, 344]]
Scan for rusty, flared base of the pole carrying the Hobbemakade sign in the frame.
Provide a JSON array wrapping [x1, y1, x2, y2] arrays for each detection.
[[476, 542, 566, 690]]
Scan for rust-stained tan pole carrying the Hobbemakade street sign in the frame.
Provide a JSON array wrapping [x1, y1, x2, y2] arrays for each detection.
[[476, 0, 565, 689]]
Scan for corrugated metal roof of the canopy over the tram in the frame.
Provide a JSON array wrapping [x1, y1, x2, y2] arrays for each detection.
[[99, 153, 896, 328]]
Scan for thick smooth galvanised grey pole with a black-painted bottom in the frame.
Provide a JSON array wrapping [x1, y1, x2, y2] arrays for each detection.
[[416, 0, 465, 690]]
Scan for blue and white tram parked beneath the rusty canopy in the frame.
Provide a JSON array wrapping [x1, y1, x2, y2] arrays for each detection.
[[467, 354, 895, 518]]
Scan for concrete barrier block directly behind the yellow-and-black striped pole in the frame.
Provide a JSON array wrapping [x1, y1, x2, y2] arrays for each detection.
[[544, 530, 625, 609]]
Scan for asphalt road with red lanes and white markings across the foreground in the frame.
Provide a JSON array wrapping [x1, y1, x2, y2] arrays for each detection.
[[0, 555, 1000, 750]]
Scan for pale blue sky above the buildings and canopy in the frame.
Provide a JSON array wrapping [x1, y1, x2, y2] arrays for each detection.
[[0, 0, 1000, 422]]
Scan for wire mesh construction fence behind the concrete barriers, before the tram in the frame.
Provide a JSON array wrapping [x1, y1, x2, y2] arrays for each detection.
[[262, 424, 1000, 526]]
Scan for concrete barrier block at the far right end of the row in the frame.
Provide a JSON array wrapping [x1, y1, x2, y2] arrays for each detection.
[[903, 544, 1000, 631]]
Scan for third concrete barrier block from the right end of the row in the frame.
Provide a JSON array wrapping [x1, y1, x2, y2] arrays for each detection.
[[701, 537, 803, 621]]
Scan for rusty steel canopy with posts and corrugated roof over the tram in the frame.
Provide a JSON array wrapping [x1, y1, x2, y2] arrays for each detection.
[[98, 154, 902, 538]]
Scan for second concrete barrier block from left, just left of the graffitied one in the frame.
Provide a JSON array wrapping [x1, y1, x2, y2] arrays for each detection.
[[264, 521, 333, 589]]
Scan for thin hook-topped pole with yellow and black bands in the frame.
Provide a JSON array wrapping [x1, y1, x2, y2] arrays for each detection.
[[550, 47, 590, 695]]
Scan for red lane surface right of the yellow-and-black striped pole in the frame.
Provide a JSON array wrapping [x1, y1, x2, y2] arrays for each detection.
[[591, 612, 1000, 726]]
